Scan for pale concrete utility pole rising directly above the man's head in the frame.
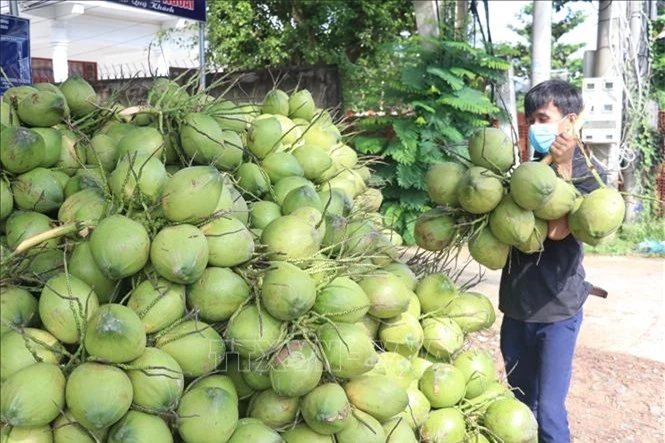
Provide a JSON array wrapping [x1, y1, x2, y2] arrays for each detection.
[[531, 0, 552, 87]]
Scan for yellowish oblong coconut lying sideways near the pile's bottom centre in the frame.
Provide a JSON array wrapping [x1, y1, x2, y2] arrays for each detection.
[[344, 375, 409, 422]]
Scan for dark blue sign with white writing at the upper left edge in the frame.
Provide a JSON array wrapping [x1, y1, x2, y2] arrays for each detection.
[[0, 15, 32, 95]]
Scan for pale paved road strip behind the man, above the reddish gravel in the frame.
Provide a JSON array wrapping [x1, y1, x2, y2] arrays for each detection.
[[456, 255, 665, 362]]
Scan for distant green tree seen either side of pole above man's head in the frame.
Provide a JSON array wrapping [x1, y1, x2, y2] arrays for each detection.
[[495, 2, 587, 82]]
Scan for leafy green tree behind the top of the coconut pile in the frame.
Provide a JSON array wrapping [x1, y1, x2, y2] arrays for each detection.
[[201, 0, 415, 108]]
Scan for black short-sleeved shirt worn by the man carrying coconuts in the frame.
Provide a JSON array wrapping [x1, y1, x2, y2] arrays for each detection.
[[499, 148, 606, 323]]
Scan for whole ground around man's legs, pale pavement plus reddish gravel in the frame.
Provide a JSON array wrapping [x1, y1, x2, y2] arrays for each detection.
[[460, 256, 665, 443]]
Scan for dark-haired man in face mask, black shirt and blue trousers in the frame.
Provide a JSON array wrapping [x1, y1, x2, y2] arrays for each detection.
[[499, 80, 604, 443]]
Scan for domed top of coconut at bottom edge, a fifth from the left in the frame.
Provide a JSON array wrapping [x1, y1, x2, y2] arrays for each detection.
[[106, 410, 173, 443]]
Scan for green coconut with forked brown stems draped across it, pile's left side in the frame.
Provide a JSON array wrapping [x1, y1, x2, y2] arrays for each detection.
[[39, 273, 99, 344]]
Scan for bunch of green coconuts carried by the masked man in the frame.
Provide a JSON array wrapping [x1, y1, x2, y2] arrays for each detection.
[[415, 128, 624, 269]]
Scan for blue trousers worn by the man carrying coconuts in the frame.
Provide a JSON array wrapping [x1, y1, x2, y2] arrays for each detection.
[[501, 309, 582, 443]]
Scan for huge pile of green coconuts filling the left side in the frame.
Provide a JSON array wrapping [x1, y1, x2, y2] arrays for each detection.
[[0, 78, 537, 443]]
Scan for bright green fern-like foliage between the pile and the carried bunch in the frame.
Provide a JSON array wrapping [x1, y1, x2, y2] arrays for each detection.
[[351, 37, 509, 244]]
